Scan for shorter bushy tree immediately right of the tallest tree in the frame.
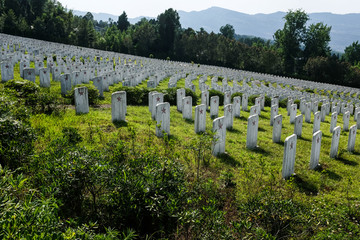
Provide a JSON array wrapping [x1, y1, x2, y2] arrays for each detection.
[[304, 23, 331, 62]]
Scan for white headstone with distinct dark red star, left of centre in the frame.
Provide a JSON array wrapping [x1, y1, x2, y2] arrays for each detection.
[[154, 102, 170, 137]]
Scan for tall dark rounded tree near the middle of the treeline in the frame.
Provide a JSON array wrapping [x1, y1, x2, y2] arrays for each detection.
[[157, 8, 181, 55]]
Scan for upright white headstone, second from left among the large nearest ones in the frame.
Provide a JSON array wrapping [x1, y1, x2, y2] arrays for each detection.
[[111, 91, 126, 122]]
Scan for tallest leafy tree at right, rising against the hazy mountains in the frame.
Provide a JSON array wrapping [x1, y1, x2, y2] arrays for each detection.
[[274, 10, 309, 74]]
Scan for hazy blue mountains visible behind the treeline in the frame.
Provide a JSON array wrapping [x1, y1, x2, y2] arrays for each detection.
[[74, 7, 360, 52]]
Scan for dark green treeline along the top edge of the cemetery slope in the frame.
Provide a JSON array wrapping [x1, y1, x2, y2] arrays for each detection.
[[0, 0, 360, 87]]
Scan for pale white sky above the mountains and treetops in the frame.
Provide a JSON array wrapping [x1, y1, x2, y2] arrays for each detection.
[[58, 0, 360, 18]]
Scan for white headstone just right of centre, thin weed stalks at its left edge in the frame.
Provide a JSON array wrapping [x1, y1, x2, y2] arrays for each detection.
[[212, 117, 226, 156]]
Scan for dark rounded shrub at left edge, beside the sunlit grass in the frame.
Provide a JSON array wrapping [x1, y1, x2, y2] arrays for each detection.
[[0, 118, 35, 169]]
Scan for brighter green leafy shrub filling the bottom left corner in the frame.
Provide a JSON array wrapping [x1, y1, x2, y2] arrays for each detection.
[[0, 165, 62, 239]]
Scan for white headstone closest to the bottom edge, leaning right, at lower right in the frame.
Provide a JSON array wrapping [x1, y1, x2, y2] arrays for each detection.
[[281, 134, 297, 179]]
